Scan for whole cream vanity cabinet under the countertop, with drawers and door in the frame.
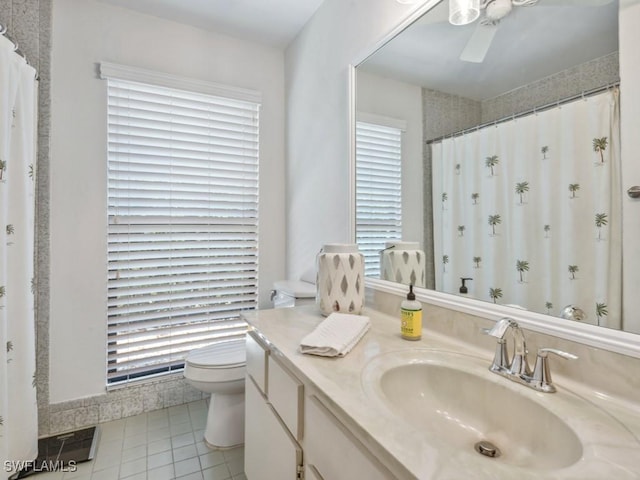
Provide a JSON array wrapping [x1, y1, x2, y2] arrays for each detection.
[[245, 332, 396, 480]]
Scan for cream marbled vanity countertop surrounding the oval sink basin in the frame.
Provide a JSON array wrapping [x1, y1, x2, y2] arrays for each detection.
[[244, 306, 640, 480]]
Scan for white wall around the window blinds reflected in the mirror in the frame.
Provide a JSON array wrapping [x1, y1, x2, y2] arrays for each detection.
[[356, 69, 424, 248]]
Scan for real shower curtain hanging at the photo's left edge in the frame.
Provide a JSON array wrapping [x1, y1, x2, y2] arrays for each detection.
[[0, 36, 38, 471]]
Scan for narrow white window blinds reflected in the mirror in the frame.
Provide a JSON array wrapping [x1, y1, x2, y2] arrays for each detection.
[[356, 122, 402, 277]]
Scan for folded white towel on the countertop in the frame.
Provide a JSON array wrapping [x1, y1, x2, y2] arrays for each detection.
[[300, 312, 371, 357]]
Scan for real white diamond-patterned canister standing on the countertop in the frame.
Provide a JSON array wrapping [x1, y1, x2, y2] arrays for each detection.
[[316, 243, 364, 316]]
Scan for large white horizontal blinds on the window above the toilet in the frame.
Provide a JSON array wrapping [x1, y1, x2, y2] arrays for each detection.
[[103, 70, 259, 383]]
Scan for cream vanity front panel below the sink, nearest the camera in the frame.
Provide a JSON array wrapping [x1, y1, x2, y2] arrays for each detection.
[[304, 396, 395, 480]]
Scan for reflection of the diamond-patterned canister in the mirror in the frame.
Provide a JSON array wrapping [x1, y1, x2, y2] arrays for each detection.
[[380, 240, 426, 287]]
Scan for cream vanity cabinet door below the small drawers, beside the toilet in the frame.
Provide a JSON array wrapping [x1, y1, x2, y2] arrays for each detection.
[[244, 376, 302, 480]]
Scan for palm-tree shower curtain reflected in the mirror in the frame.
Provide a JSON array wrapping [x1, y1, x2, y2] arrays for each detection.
[[432, 89, 622, 328]]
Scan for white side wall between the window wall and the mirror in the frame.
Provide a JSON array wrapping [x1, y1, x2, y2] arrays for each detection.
[[285, 0, 430, 278]]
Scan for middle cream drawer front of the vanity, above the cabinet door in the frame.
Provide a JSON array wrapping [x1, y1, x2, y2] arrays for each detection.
[[267, 355, 304, 441]]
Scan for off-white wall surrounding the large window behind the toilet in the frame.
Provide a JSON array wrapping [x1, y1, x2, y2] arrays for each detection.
[[50, 0, 285, 403]]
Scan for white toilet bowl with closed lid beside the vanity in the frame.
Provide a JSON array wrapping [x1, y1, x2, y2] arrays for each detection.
[[184, 338, 247, 449]]
